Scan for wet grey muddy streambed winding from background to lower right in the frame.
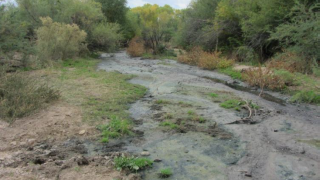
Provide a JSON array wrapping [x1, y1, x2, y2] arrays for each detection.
[[99, 52, 320, 180]]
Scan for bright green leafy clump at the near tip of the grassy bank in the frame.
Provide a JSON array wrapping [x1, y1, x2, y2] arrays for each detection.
[[98, 117, 132, 143]]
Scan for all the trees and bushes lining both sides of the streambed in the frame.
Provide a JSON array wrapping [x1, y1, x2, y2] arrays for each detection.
[[0, 0, 320, 124]]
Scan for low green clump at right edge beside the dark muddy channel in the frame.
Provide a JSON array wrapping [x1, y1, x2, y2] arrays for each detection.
[[290, 90, 320, 104]]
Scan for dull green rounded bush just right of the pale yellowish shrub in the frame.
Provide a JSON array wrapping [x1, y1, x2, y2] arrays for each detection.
[[92, 23, 123, 52]]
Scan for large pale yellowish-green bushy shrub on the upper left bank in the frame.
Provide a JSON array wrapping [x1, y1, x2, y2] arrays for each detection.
[[36, 17, 87, 60]]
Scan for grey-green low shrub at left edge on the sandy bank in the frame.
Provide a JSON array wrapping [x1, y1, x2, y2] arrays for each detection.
[[0, 74, 60, 121]]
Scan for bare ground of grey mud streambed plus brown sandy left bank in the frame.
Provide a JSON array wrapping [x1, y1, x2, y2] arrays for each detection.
[[0, 52, 320, 180]]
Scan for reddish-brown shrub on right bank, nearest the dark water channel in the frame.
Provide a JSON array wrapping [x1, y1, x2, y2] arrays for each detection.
[[243, 67, 286, 93]]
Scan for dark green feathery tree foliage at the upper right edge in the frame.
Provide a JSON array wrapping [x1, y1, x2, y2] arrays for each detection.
[[271, 3, 320, 72]]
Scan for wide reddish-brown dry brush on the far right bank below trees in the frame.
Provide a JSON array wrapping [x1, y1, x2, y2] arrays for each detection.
[[178, 47, 234, 70]]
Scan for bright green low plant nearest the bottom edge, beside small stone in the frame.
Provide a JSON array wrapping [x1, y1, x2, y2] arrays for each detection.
[[114, 156, 153, 172]]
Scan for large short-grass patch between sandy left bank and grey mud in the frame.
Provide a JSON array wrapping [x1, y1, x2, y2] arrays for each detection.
[[37, 59, 146, 142]]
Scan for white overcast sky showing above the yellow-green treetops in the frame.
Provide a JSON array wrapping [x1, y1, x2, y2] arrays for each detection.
[[0, 0, 191, 9]]
